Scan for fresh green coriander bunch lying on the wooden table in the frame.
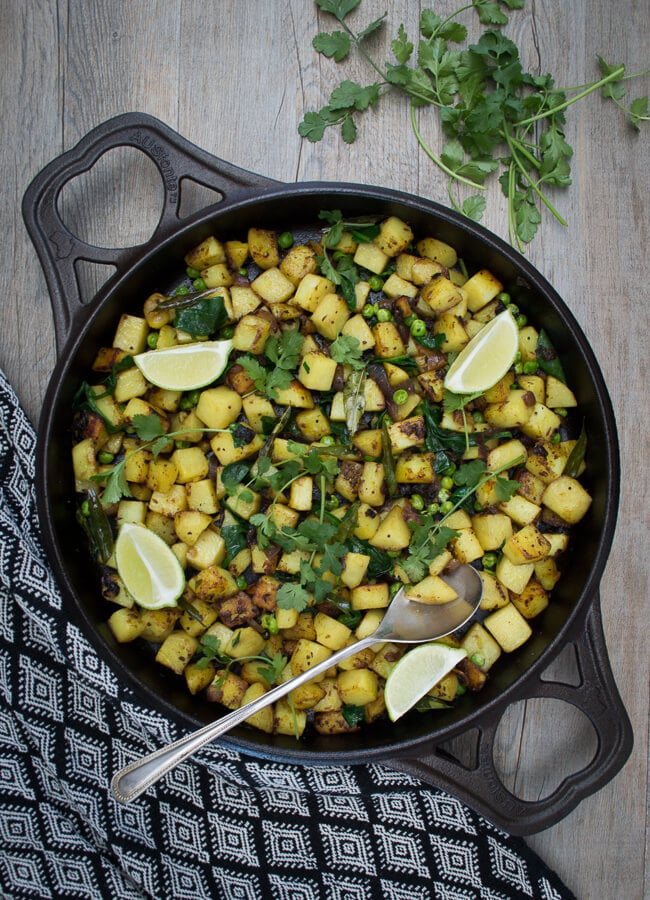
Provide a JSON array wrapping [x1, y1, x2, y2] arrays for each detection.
[[298, 0, 650, 250]]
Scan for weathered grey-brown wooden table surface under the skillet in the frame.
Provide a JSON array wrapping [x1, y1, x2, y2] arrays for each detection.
[[0, 0, 650, 900]]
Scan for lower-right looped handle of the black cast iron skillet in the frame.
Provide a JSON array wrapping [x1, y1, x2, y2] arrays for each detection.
[[389, 597, 633, 836]]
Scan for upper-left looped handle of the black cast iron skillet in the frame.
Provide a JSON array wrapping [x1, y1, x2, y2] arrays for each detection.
[[22, 112, 277, 351]]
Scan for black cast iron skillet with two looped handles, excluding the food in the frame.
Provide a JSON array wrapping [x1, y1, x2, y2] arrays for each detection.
[[23, 113, 632, 834]]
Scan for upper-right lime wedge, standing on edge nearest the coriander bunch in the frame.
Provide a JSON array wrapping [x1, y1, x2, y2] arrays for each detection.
[[445, 309, 519, 394]]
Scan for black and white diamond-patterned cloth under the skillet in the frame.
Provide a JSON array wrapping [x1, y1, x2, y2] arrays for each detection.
[[0, 372, 573, 900]]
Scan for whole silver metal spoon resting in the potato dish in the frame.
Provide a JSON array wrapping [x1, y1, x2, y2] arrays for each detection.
[[111, 565, 483, 803]]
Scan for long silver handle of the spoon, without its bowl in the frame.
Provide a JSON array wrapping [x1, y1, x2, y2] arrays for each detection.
[[111, 634, 374, 803]]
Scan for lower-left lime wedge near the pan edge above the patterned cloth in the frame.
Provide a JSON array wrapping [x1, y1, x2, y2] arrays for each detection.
[[115, 522, 185, 609]]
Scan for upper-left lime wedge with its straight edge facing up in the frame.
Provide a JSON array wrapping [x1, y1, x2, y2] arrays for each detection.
[[133, 341, 232, 391]]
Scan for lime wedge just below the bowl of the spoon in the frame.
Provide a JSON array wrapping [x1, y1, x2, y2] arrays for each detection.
[[384, 643, 467, 722]]
